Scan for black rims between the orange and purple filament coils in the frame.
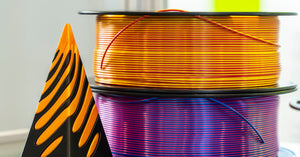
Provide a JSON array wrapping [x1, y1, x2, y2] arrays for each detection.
[[90, 79, 297, 98]]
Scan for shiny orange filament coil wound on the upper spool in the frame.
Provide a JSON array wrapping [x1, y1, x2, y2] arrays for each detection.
[[94, 15, 280, 89]]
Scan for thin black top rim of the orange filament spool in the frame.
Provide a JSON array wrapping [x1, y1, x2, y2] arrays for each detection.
[[79, 10, 297, 16]]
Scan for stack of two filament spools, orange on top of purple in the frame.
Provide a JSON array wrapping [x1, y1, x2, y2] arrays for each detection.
[[81, 10, 295, 157]]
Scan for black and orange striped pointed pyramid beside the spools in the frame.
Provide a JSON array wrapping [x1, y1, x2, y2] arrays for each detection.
[[22, 24, 112, 157]]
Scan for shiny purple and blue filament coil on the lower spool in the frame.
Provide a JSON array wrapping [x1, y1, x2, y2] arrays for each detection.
[[96, 94, 279, 157]]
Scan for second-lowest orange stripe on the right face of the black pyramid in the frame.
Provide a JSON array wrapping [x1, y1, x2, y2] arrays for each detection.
[[78, 105, 98, 148]]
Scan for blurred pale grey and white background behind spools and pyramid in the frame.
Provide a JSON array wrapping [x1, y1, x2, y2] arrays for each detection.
[[0, 0, 300, 157]]
